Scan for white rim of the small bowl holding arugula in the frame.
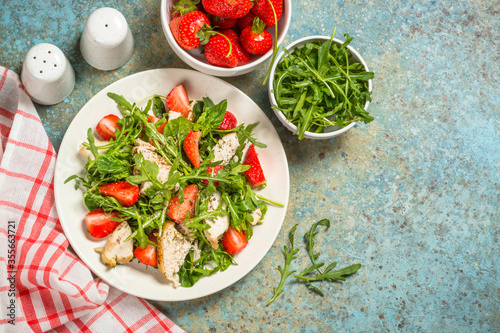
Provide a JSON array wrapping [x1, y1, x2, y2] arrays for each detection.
[[268, 35, 372, 139]]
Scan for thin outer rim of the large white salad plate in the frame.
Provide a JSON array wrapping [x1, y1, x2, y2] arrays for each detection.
[[54, 68, 290, 302]]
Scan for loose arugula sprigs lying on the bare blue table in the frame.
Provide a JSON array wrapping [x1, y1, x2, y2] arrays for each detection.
[[267, 219, 361, 305]]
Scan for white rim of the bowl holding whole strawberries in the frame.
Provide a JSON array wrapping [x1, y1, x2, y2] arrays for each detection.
[[160, 0, 292, 73]]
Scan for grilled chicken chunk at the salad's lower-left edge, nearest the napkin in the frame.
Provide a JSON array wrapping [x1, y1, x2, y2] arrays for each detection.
[[101, 221, 134, 267]]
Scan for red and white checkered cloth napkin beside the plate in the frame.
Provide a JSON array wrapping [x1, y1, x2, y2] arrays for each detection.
[[0, 67, 184, 333]]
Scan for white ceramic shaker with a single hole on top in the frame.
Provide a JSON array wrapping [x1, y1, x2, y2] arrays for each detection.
[[80, 7, 134, 71]]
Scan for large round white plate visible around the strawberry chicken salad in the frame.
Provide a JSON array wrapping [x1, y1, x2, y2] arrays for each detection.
[[54, 69, 289, 301]]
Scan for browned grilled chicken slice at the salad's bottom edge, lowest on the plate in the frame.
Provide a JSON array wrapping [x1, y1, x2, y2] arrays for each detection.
[[156, 221, 192, 288]]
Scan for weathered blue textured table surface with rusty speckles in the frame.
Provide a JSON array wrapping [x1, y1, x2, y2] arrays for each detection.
[[0, 0, 500, 332]]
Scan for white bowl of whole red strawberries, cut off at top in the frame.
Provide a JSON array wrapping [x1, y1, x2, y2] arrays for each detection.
[[160, 0, 292, 77]]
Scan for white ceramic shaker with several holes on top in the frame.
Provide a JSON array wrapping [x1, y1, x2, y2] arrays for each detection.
[[21, 43, 75, 105]]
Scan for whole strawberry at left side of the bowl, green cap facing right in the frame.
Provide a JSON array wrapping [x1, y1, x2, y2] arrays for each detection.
[[168, 10, 210, 50]]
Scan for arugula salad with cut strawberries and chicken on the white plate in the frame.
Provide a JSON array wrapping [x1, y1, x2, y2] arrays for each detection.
[[66, 85, 279, 287]]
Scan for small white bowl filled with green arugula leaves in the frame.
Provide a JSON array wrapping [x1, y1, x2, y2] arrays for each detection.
[[269, 32, 374, 140]]
